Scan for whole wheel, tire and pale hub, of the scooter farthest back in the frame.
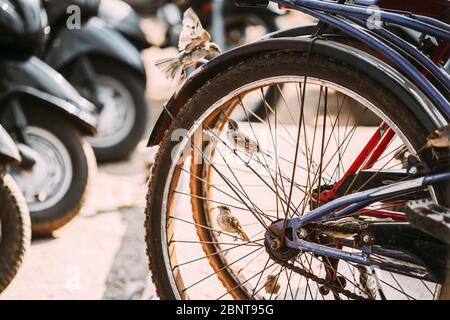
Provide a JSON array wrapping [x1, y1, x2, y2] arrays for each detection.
[[80, 57, 148, 162]]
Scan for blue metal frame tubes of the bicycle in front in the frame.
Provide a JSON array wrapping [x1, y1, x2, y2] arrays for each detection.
[[266, 0, 450, 278]]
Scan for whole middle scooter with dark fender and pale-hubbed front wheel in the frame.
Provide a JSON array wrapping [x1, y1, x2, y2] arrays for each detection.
[[0, 0, 96, 234]]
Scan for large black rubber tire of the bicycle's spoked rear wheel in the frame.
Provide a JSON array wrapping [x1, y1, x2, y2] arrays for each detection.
[[145, 51, 450, 299]]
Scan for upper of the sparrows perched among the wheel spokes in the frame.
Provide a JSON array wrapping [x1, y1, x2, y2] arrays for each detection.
[[227, 119, 272, 165]]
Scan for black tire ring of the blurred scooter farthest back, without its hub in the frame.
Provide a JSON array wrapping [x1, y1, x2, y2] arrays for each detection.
[[86, 56, 149, 162]]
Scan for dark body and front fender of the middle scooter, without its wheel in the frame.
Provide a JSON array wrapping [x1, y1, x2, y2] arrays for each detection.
[[0, 0, 96, 135]]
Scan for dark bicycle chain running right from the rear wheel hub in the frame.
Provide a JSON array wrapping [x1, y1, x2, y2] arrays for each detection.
[[266, 223, 369, 300]]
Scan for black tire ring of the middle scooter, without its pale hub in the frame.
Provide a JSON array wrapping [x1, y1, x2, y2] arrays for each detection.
[[15, 106, 97, 236]]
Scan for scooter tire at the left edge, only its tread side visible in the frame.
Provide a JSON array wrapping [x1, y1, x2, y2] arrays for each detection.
[[0, 173, 31, 293]]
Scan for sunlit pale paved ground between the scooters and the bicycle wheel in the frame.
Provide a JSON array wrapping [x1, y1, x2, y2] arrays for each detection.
[[0, 11, 316, 299]]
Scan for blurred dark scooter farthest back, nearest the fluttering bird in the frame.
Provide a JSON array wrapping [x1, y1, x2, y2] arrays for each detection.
[[43, 0, 148, 161]]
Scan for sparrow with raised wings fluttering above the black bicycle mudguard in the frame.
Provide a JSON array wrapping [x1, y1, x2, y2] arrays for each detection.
[[155, 8, 221, 80]]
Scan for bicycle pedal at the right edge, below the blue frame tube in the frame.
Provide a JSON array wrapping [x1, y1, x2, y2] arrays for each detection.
[[406, 200, 450, 245]]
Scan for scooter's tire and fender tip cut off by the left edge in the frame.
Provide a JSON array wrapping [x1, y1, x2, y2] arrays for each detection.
[[0, 126, 31, 293]]
